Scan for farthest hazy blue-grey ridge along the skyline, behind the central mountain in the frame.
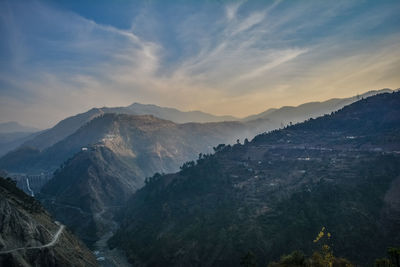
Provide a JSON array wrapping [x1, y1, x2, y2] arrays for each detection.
[[0, 89, 391, 173]]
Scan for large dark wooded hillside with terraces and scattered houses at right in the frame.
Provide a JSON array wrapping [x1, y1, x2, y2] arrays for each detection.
[[109, 92, 400, 266]]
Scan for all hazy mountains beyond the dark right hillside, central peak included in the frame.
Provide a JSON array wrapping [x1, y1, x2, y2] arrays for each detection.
[[0, 89, 392, 266]]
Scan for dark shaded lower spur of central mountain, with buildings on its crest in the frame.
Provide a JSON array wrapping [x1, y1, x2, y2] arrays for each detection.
[[38, 146, 144, 243]]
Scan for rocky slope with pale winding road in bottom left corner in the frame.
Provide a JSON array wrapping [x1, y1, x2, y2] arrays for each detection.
[[0, 178, 97, 267]]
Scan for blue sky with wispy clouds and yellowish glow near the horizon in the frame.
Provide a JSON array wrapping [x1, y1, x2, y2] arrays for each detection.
[[0, 0, 400, 128]]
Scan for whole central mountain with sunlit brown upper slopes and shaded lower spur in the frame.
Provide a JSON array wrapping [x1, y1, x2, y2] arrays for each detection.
[[31, 114, 244, 243]]
